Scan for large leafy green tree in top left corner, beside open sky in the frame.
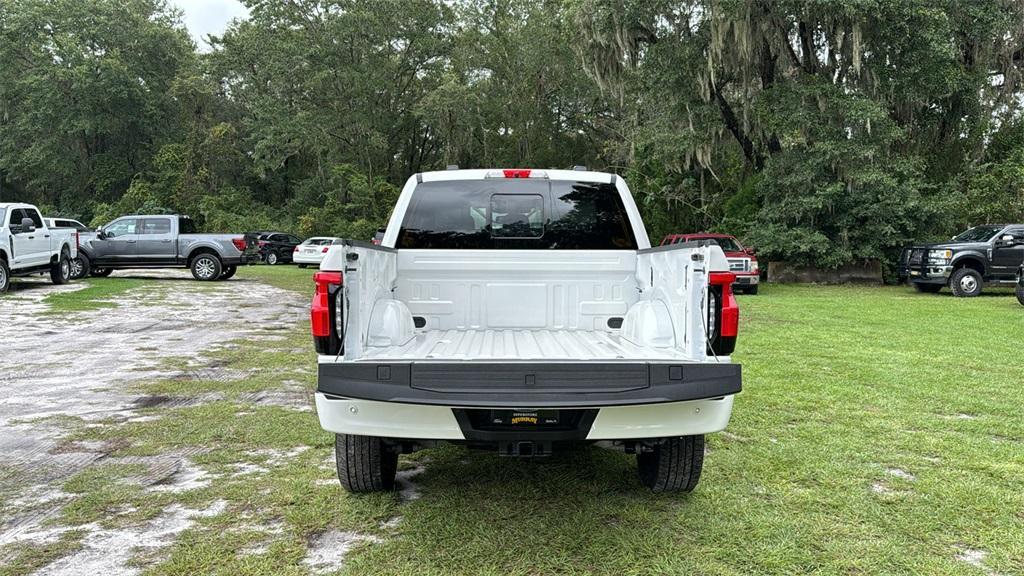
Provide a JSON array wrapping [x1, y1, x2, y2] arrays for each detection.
[[0, 0, 196, 212]]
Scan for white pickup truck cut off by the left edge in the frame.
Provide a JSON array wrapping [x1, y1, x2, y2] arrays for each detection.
[[0, 203, 78, 293]]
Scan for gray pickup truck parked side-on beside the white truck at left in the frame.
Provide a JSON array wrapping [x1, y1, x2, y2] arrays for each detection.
[[78, 214, 259, 281]]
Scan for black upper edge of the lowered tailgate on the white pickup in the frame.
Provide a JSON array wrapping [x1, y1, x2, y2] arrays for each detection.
[[316, 362, 742, 408]]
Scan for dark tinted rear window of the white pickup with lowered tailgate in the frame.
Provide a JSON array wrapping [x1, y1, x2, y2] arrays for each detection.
[[397, 178, 637, 250]]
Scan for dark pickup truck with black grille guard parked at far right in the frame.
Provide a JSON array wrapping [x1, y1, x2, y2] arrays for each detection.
[[899, 224, 1024, 296]]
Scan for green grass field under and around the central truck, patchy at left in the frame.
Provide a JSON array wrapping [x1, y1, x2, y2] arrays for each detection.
[[8, 266, 1024, 575]]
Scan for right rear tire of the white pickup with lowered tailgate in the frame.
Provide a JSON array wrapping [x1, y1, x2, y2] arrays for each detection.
[[637, 435, 703, 492]]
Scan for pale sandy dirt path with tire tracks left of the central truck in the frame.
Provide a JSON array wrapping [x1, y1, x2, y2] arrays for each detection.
[[0, 271, 307, 574]]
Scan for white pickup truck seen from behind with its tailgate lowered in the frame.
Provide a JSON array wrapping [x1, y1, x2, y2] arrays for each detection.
[[311, 170, 741, 492]]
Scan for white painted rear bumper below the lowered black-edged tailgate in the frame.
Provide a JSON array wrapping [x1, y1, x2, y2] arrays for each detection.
[[316, 393, 733, 441]]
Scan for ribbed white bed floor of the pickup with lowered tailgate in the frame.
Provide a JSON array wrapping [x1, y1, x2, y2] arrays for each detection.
[[358, 330, 687, 362]]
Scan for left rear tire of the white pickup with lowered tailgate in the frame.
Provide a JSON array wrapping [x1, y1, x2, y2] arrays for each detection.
[[334, 434, 398, 492]]
